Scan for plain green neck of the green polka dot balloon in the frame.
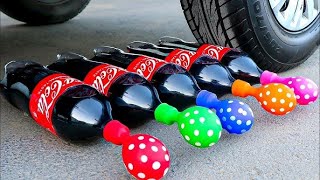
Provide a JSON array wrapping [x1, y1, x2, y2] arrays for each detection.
[[154, 103, 179, 125]]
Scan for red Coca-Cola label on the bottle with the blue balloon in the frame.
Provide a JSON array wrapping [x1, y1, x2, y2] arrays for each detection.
[[127, 56, 166, 81]]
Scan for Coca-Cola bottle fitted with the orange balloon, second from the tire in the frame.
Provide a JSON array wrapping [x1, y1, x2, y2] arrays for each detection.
[[127, 41, 235, 96]]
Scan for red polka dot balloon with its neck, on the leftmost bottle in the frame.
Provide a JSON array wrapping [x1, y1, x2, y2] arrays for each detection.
[[103, 120, 170, 179]]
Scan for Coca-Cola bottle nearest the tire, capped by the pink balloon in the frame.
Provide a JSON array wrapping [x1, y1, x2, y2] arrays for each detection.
[[159, 36, 262, 84]]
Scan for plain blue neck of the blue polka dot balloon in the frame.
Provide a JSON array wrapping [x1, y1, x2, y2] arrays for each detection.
[[196, 90, 220, 109]]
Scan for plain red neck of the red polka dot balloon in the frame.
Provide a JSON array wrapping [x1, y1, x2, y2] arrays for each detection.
[[103, 120, 130, 145]]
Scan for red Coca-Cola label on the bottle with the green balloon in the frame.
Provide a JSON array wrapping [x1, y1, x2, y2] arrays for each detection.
[[84, 64, 127, 95]]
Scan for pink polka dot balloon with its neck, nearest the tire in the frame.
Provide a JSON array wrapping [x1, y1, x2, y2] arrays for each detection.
[[260, 71, 319, 105]]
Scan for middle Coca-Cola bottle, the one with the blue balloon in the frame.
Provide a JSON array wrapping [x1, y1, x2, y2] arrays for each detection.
[[92, 46, 200, 109]]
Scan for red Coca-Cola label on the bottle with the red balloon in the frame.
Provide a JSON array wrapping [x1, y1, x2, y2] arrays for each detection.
[[29, 74, 83, 134]]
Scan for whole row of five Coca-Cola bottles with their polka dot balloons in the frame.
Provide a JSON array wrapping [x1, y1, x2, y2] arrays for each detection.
[[1, 37, 318, 179]]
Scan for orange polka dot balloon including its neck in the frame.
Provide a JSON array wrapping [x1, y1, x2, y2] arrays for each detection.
[[231, 80, 297, 115]]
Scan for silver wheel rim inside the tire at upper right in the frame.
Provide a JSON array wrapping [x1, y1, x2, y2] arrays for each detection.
[[269, 0, 320, 31]]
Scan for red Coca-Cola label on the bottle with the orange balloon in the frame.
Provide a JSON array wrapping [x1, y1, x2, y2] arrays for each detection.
[[165, 49, 201, 70]]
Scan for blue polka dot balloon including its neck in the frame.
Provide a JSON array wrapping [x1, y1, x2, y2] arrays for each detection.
[[196, 90, 254, 134]]
